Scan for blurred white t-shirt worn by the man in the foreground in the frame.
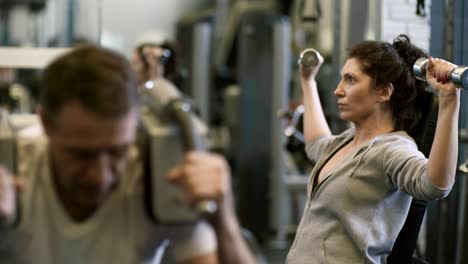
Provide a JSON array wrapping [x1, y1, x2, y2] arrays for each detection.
[[0, 137, 217, 264]]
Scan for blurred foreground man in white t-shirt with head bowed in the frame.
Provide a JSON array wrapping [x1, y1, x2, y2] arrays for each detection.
[[0, 46, 253, 263]]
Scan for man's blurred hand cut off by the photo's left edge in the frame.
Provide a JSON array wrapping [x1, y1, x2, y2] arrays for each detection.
[[0, 165, 24, 227]]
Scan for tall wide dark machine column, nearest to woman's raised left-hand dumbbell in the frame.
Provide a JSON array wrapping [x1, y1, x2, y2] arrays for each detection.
[[236, 12, 291, 243]]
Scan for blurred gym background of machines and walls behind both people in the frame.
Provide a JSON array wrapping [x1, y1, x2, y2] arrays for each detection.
[[0, 0, 468, 264]]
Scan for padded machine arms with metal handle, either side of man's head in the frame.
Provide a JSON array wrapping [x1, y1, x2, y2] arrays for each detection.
[[0, 81, 217, 223]]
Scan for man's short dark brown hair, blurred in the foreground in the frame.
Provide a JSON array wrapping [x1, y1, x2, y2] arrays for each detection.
[[40, 46, 138, 124]]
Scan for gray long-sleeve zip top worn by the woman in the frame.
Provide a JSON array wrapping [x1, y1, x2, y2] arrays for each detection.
[[286, 129, 450, 264]]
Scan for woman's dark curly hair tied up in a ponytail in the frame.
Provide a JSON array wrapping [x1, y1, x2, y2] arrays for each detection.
[[348, 35, 428, 132]]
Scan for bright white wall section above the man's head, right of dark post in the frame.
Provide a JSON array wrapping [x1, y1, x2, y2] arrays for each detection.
[[75, 0, 209, 54]]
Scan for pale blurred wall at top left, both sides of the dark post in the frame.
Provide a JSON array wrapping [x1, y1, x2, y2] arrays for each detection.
[[9, 0, 215, 54]]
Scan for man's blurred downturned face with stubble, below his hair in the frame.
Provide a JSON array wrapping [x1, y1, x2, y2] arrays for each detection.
[[43, 102, 137, 216]]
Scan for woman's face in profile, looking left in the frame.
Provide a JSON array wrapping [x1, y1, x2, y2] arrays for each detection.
[[334, 58, 378, 123]]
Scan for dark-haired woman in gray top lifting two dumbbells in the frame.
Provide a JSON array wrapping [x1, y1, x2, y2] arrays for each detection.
[[286, 35, 460, 264]]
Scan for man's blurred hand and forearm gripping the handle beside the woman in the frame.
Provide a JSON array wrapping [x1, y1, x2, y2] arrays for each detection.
[[168, 152, 256, 264]]
